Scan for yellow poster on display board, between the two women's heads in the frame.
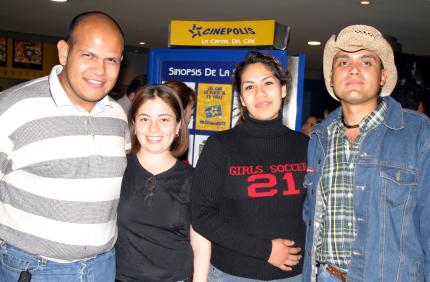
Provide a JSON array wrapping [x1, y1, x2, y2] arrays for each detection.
[[196, 83, 233, 131]]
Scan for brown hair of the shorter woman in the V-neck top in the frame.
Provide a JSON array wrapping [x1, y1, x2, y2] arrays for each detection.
[[128, 85, 189, 157]]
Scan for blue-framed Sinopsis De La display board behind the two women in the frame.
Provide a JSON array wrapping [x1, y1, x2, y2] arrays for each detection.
[[148, 48, 304, 166]]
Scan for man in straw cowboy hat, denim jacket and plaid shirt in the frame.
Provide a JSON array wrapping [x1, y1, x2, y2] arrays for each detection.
[[303, 25, 430, 282]]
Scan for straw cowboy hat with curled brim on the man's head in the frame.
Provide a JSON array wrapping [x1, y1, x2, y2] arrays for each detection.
[[323, 25, 397, 100]]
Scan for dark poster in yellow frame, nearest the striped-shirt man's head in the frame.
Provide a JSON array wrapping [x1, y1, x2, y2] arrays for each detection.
[[12, 39, 43, 70]]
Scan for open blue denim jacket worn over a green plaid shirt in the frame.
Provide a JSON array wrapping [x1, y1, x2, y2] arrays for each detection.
[[303, 97, 430, 282]]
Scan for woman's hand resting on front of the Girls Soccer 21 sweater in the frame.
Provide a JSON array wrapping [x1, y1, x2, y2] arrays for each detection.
[[268, 238, 302, 271]]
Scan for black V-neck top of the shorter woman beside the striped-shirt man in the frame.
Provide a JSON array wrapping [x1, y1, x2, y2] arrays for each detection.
[[116, 154, 193, 282]]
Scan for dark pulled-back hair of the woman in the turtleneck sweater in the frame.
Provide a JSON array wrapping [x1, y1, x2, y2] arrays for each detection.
[[233, 51, 289, 123]]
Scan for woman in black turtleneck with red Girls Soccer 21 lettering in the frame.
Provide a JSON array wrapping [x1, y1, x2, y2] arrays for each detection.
[[191, 52, 308, 282]]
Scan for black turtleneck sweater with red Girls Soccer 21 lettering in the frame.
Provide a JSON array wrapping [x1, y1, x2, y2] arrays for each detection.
[[191, 114, 308, 280]]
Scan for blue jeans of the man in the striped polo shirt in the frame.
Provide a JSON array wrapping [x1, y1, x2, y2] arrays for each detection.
[[0, 242, 115, 282]]
